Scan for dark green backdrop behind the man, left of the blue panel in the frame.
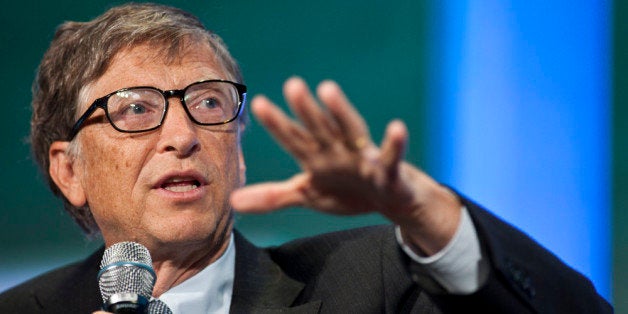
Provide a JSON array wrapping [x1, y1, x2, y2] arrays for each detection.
[[0, 0, 427, 288]]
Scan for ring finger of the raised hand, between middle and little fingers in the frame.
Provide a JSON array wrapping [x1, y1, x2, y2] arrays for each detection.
[[317, 80, 372, 149]]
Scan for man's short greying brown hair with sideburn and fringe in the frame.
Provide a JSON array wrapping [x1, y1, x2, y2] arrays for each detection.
[[30, 3, 246, 235]]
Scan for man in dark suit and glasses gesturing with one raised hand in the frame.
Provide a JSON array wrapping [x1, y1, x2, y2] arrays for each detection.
[[0, 4, 612, 313]]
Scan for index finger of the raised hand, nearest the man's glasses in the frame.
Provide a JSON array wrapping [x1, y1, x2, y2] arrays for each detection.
[[251, 96, 313, 160]]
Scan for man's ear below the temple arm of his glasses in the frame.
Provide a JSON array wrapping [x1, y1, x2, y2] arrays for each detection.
[[48, 141, 87, 207]]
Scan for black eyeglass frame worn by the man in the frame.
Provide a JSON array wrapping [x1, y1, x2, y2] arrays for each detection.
[[68, 80, 246, 141]]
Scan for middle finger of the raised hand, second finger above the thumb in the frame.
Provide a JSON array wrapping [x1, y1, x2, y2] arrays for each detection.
[[284, 77, 339, 147]]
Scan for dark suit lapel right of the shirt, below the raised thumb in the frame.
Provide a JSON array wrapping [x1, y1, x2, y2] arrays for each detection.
[[231, 231, 321, 313]]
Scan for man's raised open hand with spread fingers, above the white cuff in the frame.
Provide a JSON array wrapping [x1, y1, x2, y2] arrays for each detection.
[[231, 78, 460, 254]]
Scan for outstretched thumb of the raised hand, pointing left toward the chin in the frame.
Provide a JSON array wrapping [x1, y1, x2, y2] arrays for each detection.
[[230, 174, 305, 213]]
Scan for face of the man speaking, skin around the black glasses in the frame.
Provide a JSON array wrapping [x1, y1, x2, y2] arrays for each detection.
[[67, 44, 244, 248]]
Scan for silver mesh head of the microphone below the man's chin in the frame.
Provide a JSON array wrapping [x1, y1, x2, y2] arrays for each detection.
[[98, 242, 155, 310]]
